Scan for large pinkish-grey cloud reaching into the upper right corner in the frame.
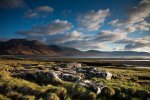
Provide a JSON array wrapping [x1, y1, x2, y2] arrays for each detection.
[[109, 0, 150, 33]]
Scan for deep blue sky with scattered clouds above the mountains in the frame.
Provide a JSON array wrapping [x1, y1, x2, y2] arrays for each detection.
[[0, 0, 150, 52]]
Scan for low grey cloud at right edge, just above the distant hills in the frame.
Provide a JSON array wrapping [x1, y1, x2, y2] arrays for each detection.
[[116, 37, 150, 50]]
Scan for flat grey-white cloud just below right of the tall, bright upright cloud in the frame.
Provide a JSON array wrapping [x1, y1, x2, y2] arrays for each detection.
[[94, 30, 126, 42]]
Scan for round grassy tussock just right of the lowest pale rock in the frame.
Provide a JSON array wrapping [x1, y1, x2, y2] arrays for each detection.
[[101, 87, 115, 97]]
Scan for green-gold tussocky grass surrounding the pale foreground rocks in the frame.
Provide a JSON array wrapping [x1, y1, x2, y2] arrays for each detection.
[[0, 59, 150, 100]]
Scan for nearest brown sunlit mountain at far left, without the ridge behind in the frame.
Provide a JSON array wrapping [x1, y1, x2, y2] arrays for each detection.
[[0, 39, 59, 56]]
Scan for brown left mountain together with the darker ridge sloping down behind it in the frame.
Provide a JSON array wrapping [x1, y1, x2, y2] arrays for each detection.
[[0, 39, 82, 56]]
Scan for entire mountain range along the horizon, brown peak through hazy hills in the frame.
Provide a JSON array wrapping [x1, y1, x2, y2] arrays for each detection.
[[0, 39, 150, 57]]
